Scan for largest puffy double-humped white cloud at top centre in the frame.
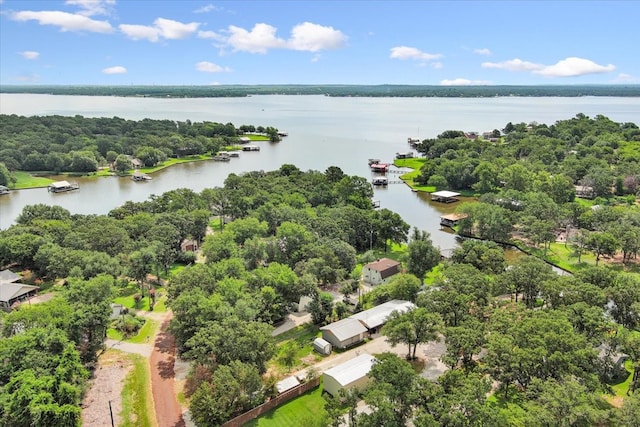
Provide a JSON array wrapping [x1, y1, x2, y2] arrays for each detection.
[[224, 22, 347, 53]]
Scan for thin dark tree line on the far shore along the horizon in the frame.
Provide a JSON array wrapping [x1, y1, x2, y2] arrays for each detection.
[[0, 85, 640, 98]]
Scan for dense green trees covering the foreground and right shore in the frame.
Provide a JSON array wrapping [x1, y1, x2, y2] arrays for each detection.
[[0, 115, 640, 427]]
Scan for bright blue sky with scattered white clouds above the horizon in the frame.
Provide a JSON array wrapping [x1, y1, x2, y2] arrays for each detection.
[[0, 0, 640, 85]]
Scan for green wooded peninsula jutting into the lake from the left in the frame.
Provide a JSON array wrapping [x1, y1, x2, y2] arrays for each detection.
[[0, 114, 280, 181]]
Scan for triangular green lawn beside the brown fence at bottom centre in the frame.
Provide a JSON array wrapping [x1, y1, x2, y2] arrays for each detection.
[[245, 386, 327, 427]]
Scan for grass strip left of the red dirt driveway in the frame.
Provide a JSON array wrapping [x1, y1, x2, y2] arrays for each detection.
[[120, 354, 157, 427]]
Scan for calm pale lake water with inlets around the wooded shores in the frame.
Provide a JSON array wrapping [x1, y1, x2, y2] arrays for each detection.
[[0, 94, 640, 250]]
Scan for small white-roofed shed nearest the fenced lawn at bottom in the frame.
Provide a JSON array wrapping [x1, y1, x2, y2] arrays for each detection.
[[322, 354, 376, 397]]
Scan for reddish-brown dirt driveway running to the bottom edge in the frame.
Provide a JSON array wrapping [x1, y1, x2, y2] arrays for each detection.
[[150, 313, 185, 427]]
